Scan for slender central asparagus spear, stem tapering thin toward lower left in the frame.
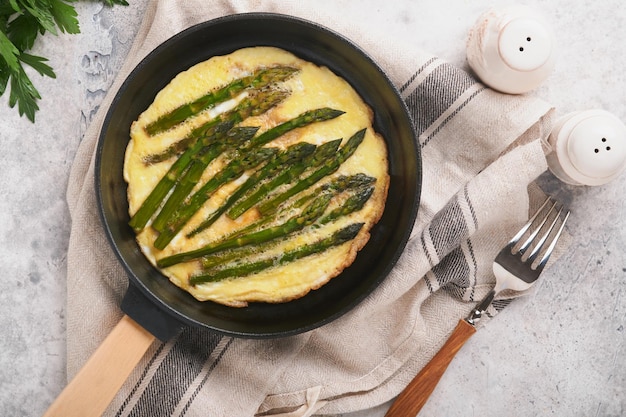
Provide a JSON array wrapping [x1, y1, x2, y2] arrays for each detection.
[[187, 142, 316, 237]]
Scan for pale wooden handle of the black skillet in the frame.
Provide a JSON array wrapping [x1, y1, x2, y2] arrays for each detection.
[[43, 315, 155, 417]]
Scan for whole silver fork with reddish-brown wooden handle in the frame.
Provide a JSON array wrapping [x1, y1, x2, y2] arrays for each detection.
[[385, 198, 570, 417]]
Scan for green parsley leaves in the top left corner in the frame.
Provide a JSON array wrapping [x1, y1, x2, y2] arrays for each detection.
[[0, 0, 128, 122]]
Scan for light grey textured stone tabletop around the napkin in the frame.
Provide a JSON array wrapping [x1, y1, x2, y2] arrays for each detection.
[[0, 0, 626, 417]]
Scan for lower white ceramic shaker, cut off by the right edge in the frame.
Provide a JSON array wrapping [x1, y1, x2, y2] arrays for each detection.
[[546, 109, 626, 185]]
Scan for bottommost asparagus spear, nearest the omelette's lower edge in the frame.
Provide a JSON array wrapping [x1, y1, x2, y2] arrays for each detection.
[[189, 223, 363, 285]]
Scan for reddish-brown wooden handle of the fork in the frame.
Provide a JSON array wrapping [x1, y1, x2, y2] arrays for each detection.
[[385, 320, 476, 417]]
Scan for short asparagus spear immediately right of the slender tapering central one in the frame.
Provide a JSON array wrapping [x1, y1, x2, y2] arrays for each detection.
[[227, 139, 341, 220]]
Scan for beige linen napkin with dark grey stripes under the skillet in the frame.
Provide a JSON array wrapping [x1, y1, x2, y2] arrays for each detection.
[[67, 0, 551, 417]]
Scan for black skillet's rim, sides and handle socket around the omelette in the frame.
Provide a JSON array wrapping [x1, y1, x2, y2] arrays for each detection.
[[95, 13, 421, 340]]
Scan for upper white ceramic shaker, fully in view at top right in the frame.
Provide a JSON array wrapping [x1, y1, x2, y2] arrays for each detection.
[[466, 6, 555, 94]]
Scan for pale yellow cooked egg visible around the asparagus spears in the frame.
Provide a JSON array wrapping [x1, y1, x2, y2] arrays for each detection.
[[124, 47, 389, 307]]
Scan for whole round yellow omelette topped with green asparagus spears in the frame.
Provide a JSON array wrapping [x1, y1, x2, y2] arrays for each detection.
[[124, 47, 389, 307]]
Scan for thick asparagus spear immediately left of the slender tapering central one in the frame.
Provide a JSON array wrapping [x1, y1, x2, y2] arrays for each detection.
[[154, 148, 276, 249]]
